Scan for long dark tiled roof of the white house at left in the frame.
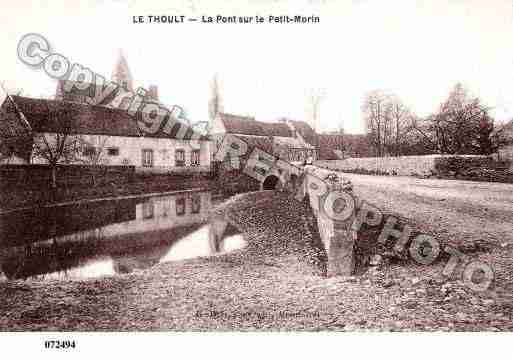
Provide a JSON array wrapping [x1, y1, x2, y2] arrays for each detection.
[[4, 96, 203, 138]]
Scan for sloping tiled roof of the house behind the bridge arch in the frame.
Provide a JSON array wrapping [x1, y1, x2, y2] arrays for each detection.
[[219, 113, 293, 137]]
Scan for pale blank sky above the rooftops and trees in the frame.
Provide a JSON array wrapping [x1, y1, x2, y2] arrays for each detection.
[[0, 0, 513, 133]]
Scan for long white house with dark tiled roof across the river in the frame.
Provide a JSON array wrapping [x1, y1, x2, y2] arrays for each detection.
[[4, 96, 211, 173]]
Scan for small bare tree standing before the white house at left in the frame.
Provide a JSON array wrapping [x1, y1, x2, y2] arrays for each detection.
[[32, 104, 84, 188]]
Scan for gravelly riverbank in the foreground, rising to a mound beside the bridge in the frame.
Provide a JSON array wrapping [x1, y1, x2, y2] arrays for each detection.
[[0, 191, 513, 331]]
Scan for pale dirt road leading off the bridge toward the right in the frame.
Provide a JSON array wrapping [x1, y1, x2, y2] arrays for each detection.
[[343, 173, 513, 250]]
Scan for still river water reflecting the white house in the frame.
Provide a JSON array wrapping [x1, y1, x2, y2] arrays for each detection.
[[0, 192, 245, 280]]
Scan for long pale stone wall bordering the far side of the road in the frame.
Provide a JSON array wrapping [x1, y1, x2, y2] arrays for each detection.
[[315, 155, 485, 176]]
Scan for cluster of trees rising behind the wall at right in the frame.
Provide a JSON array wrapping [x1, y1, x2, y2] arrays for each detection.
[[362, 83, 505, 157]]
